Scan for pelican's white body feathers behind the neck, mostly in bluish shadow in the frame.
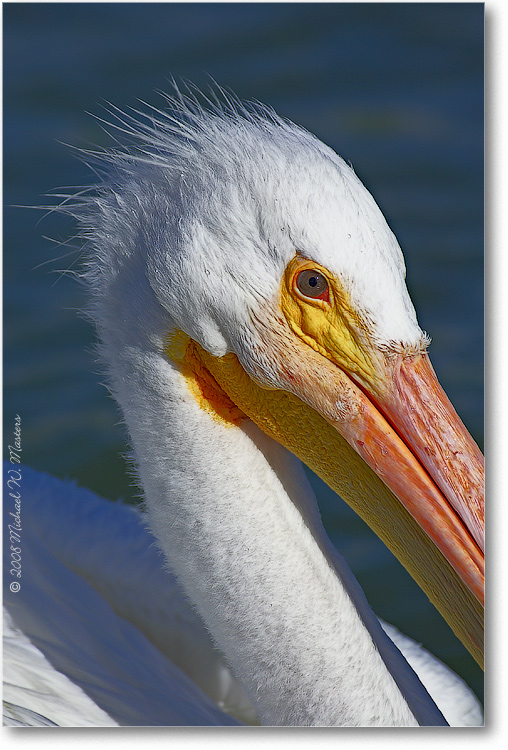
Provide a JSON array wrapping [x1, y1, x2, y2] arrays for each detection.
[[3, 464, 482, 727]]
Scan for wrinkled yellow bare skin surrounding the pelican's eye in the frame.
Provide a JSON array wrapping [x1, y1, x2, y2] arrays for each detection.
[[281, 255, 382, 393]]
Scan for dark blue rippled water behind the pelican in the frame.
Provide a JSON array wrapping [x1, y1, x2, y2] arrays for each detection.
[[3, 3, 483, 695]]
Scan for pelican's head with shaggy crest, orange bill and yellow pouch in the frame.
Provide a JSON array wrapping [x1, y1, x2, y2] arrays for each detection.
[[69, 88, 483, 700]]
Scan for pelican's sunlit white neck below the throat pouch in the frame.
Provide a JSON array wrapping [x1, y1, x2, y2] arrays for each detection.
[[106, 328, 440, 726]]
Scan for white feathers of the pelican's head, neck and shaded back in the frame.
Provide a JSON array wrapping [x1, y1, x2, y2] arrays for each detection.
[[2, 88, 481, 726]]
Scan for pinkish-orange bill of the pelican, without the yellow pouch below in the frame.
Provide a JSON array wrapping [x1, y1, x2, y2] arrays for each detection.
[[322, 355, 484, 604]]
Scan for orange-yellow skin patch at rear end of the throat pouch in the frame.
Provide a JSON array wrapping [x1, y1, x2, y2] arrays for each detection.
[[165, 330, 248, 427]]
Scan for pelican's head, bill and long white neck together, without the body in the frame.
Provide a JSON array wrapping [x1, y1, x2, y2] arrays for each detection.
[[3, 88, 483, 726]]
